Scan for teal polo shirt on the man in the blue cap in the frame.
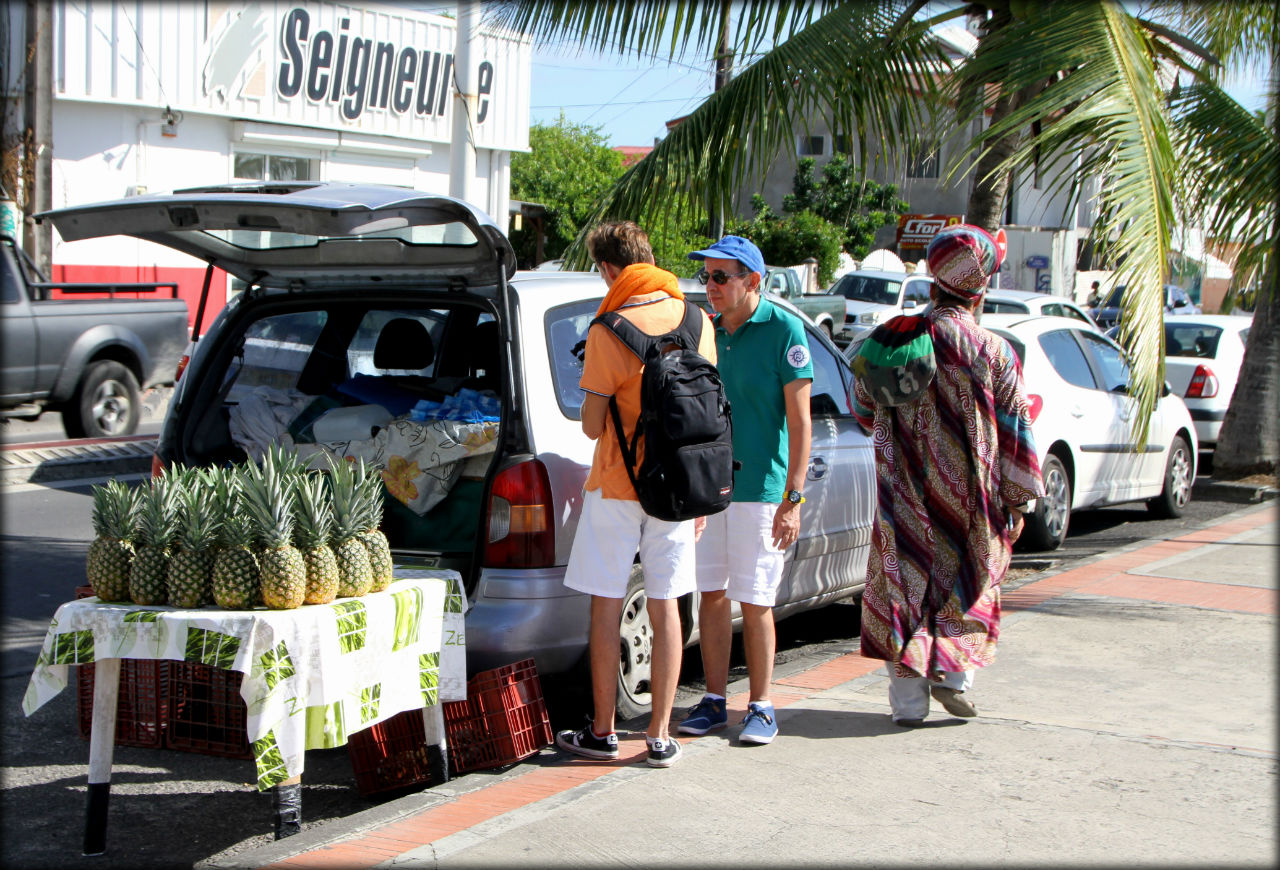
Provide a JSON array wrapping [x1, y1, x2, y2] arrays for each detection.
[[712, 296, 813, 503]]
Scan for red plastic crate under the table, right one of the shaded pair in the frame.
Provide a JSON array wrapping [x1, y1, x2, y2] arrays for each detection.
[[165, 661, 253, 759]]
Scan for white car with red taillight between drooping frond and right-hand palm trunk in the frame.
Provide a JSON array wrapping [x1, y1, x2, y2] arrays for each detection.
[[1165, 315, 1253, 450]]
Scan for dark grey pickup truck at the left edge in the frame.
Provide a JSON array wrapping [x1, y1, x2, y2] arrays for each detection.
[[0, 235, 187, 438]]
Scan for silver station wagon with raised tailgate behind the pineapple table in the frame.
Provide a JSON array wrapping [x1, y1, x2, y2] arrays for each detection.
[[37, 183, 874, 716]]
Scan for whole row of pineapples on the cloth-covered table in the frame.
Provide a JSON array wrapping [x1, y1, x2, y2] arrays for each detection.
[[86, 445, 392, 610]]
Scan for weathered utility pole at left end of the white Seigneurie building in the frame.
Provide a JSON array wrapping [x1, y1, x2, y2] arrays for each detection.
[[22, 0, 54, 275]]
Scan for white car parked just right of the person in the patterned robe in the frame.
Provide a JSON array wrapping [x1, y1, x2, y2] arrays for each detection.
[[992, 317, 1198, 550]]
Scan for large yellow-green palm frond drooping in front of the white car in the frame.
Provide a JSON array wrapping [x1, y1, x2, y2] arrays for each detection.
[[957, 0, 1178, 440]]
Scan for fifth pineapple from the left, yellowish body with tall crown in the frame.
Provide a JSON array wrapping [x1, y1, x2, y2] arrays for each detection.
[[242, 450, 307, 610]]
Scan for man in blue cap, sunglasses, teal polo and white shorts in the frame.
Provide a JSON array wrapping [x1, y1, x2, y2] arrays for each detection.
[[678, 235, 813, 743]]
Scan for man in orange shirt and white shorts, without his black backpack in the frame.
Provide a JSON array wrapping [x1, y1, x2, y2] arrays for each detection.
[[556, 221, 716, 768]]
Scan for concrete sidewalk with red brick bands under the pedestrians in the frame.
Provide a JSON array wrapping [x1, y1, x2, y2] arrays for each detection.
[[207, 502, 1277, 870]]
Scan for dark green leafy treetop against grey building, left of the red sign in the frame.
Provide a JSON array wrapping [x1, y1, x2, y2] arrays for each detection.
[[782, 154, 911, 260]]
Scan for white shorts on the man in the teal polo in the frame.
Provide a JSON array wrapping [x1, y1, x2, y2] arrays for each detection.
[[698, 502, 786, 608]]
